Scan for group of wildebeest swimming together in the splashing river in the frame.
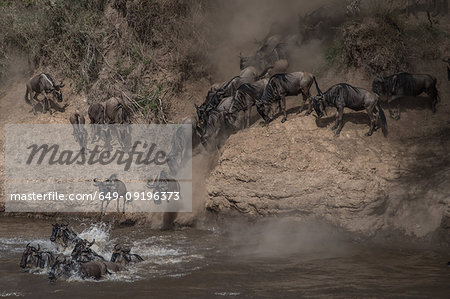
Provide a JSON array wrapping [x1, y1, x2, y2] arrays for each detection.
[[19, 223, 144, 281]]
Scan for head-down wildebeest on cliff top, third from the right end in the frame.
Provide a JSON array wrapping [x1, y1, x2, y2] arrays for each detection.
[[256, 72, 314, 123]]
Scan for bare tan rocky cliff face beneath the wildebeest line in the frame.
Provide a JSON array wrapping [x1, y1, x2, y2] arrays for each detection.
[[206, 98, 450, 237]]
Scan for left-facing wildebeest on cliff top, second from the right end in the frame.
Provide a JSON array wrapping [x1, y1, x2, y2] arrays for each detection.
[[312, 82, 387, 136]]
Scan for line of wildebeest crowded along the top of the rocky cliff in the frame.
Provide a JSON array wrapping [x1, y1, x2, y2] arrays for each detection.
[[195, 35, 440, 150]]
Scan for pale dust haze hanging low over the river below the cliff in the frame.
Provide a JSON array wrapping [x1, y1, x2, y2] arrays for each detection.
[[227, 218, 351, 259]]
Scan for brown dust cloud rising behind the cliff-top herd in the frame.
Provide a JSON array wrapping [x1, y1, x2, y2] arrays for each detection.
[[202, 0, 333, 81]]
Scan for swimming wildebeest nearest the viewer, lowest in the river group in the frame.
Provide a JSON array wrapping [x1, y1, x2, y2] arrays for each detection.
[[48, 257, 110, 281]]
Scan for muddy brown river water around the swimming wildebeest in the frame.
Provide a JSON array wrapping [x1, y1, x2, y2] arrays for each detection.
[[0, 217, 450, 298]]
